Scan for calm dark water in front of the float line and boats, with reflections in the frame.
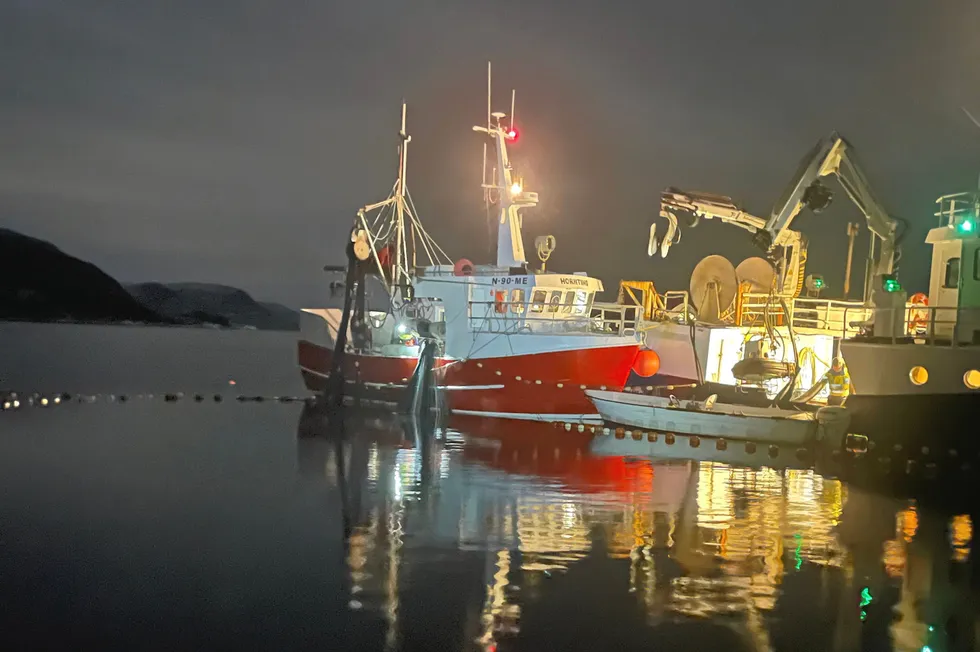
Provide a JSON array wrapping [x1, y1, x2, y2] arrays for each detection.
[[0, 324, 978, 652]]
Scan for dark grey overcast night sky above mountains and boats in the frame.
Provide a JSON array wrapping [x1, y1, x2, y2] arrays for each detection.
[[0, 0, 980, 307]]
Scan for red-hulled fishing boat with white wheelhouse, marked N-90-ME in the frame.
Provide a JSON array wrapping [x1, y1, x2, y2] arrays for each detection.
[[298, 67, 643, 421]]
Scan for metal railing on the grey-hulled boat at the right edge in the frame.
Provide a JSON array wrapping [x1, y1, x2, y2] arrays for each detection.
[[838, 305, 980, 347]]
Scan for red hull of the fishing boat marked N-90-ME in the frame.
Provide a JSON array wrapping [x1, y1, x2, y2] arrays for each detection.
[[299, 340, 639, 420]]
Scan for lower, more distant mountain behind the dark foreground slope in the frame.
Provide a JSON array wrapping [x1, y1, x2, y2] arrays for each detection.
[[126, 283, 299, 330]]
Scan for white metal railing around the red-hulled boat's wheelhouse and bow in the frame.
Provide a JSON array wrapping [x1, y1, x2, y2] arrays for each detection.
[[469, 301, 643, 335]]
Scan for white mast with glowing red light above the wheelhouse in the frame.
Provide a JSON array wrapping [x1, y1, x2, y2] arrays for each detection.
[[473, 63, 538, 268]]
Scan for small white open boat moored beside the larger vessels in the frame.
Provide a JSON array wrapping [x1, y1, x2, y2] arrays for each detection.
[[586, 390, 849, 445]]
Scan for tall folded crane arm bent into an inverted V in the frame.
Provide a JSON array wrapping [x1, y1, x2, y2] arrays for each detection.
[[765, 132, 898, 275]]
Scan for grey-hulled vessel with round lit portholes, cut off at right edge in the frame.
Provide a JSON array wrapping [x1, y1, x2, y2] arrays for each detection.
[[840, 191, 980, 444]]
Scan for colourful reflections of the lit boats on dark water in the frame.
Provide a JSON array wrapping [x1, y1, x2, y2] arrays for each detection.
[[299, 404, 976, 652]]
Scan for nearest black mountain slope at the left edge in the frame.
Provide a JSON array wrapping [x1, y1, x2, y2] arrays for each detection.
[[0, 228, 174, 324]]
